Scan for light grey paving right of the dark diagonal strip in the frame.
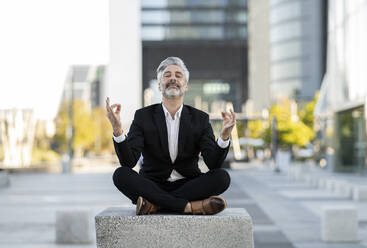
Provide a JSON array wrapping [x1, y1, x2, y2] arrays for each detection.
[[232, 167, 367, 248]]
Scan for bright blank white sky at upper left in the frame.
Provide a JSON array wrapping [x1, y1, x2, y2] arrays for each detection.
[[0, 0, 109, 120]]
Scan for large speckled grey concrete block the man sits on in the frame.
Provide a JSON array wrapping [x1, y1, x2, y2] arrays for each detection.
[[95, 207, 254, 248]]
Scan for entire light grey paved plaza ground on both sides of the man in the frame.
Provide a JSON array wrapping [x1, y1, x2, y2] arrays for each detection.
[[0, 163, 367, 248]]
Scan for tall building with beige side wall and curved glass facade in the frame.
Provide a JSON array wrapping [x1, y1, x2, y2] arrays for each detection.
[[248, 0, 326, 110]]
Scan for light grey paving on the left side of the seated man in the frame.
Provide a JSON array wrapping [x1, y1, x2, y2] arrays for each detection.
[[0, 174, 131, 248]]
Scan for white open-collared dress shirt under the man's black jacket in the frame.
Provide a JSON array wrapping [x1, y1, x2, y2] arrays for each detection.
[[113, 103, 229, 182]]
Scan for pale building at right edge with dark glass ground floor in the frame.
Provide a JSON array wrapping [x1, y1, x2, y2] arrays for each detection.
[[315, 0, 367, 173]]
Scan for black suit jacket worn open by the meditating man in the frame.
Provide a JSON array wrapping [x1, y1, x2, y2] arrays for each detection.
[[113, 104, 229, 182]]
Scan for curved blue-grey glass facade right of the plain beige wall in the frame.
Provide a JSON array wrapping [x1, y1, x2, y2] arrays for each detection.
[[269, 0, 326, 101]]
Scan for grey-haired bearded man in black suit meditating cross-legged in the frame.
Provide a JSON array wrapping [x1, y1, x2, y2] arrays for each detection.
[[106, 57, 236, 215]]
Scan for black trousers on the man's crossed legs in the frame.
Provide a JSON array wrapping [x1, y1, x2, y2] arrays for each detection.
[[113, 167, 230, 213]]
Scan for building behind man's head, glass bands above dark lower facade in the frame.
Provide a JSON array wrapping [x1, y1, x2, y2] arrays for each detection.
[[141, 0, 247, 112]]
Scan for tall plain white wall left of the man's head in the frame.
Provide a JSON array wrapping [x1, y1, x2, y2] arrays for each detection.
[[105, 0, 142, 128]]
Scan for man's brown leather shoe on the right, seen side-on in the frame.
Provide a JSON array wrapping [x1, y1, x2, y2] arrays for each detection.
[[190, 196, 227, 215]]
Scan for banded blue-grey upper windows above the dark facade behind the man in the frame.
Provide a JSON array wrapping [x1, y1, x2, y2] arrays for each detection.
[[141, 0, 247, 40]]
